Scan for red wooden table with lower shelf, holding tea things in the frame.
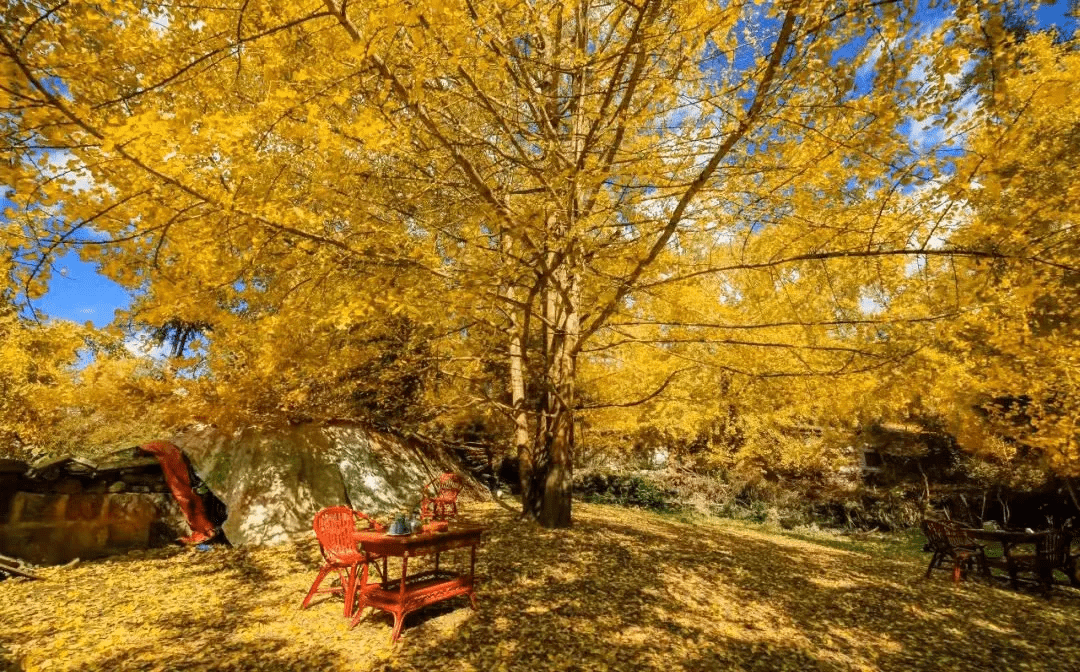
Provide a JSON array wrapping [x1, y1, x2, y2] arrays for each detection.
[[349, 527, 484, 642]]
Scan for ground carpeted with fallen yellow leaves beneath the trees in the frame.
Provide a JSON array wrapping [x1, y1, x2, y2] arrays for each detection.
[[0, 503, 1080, 672]]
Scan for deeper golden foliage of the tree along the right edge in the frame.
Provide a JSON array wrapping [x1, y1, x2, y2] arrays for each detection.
[[928, 26, 1080, 476]]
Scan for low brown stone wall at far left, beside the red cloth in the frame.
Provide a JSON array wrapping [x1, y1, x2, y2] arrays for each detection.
[[0, 492, 183, 565]]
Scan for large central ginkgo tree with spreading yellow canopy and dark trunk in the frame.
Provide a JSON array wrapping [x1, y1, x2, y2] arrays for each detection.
[[0, 0, 1067, 526]]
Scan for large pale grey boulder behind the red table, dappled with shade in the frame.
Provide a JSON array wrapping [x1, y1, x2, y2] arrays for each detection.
[[173, 424, 475, 546]]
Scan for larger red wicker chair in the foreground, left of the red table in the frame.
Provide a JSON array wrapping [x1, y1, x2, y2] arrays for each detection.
[[300, 507, 386, 618]]
